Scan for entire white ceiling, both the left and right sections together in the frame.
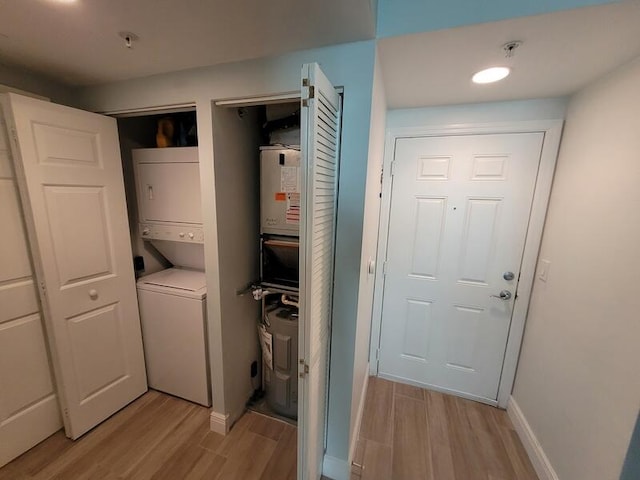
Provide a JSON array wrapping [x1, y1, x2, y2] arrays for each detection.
[[0, 0, 640, 108]]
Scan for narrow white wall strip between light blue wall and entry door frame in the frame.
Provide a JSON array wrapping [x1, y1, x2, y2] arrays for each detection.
[[348, 49, 387, 458]]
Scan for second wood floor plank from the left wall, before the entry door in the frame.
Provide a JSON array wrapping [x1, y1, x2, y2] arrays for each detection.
[[390, 395, 431, 480]]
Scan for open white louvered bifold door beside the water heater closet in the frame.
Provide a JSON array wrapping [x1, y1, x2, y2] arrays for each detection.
[[298, 63, 342, 480]]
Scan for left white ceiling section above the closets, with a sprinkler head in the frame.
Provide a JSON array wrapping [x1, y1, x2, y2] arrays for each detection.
[[0, 0, 375, 85]]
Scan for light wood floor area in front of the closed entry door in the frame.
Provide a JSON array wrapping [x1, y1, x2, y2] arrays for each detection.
[[351, 377, 538, 480]]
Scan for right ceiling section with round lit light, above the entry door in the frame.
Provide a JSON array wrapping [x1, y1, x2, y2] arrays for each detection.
[[378, 0, 640, 108]]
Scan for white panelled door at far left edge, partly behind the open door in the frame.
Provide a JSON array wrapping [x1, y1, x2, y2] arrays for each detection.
[[0, 104, 62, 467]]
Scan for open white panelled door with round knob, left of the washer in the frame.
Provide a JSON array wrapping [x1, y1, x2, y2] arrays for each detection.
[[3, 94, 147, 439]]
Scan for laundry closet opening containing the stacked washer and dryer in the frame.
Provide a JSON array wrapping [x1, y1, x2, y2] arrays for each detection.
[[117, 107, 211, 407]]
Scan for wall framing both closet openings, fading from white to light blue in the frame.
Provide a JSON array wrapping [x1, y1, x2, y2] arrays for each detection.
[[78, 41, 375, 463]]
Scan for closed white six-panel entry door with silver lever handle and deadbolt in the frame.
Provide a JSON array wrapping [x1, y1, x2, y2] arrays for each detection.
[[379, 133, 544, 403]]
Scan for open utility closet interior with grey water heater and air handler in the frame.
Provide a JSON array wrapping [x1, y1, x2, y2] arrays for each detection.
[[212, 95, 301, 425]]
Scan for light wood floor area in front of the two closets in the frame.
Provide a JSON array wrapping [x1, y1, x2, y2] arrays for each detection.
[[0, 391, 297, 480]]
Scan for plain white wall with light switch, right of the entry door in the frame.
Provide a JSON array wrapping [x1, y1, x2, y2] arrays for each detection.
[[513, 59, 640, 480]]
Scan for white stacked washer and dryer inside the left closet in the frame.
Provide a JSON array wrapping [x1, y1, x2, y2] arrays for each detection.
[[132, 147, 211, 406]]
